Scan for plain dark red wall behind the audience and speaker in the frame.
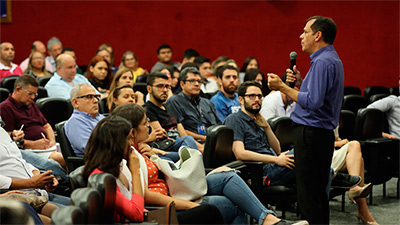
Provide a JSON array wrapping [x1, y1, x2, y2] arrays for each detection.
[[0, 0, 400, 92]]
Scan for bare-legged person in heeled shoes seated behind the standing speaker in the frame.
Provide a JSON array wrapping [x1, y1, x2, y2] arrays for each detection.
[[331, 127, 378, 225]]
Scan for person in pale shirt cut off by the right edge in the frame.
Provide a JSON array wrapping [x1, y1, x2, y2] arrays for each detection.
[[367, 76, 400, 139]]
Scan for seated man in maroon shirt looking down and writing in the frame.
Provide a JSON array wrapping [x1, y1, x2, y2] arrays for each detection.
[[0, 75, 67, 178]]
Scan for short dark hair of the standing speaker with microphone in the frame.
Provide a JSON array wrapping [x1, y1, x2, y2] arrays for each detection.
[[307, 16, 336, 45]]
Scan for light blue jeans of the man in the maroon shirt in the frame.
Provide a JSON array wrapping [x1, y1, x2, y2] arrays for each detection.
[[20, 149, 69, 181]]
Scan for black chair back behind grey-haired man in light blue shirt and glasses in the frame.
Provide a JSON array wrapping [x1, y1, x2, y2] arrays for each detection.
[[55, 121, 84, 172]]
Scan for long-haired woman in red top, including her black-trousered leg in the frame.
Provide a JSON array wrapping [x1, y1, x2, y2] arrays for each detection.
[[83, 116, 221, 224]]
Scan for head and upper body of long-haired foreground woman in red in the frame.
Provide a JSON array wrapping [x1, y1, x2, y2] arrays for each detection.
[[83, 116, 144, 222]]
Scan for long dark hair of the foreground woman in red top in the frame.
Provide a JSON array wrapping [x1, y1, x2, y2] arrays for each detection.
[[83, 116, 132, 179]]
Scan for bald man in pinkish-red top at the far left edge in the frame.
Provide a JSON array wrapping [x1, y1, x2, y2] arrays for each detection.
[[0, 42, 24, 80]]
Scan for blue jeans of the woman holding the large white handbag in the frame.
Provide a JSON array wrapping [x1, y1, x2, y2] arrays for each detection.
[[202, 171, 276, 224]]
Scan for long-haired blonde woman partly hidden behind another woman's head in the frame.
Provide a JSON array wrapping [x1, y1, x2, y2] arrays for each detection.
[[107, 68, 144, 109]]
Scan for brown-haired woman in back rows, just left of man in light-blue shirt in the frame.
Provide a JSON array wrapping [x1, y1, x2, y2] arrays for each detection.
[[24, 51, 51, 78]]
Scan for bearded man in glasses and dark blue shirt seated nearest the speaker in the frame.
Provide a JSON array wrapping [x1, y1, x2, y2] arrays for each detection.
[[225, 81, 361, 187]]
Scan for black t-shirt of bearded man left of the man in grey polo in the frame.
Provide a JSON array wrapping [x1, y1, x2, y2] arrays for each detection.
[[143, 101, 179, 139]]
